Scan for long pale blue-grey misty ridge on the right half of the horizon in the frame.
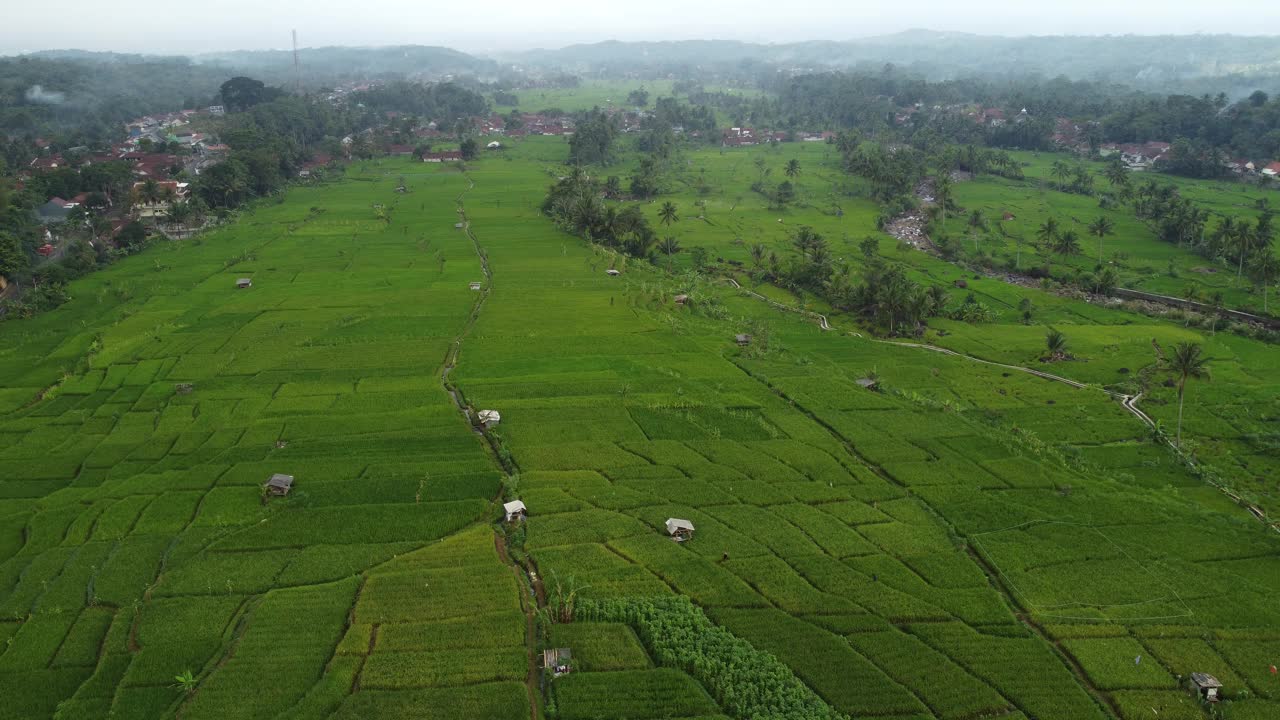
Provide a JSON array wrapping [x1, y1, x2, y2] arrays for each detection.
[[503, 29, 1280, 92]]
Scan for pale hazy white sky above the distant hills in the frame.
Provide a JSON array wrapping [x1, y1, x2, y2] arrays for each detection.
[[0, 0, 1280, 54]]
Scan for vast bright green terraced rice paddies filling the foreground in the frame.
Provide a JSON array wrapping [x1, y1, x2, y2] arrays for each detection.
[[0, 138, 1280, 720]]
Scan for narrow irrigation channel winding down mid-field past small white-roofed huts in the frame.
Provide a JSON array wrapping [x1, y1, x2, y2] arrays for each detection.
[[440, 176, 543, 720]]
